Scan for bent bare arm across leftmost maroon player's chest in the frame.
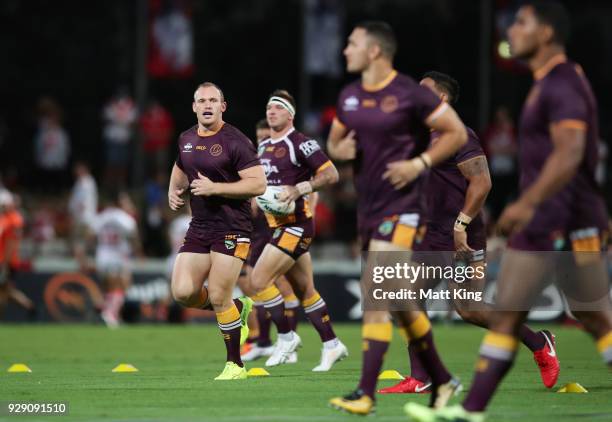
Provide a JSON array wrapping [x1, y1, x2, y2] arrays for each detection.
[[191, 165, 267, 199]]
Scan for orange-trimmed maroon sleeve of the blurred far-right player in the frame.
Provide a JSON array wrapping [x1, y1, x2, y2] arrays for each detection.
[[546, 78, 589, 130]]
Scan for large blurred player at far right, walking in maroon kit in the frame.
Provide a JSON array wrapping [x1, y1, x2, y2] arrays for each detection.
[[405, 1, 612, 421]]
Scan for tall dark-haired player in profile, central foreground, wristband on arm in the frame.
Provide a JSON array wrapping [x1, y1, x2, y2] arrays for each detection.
[[328, 22, 467, 414]]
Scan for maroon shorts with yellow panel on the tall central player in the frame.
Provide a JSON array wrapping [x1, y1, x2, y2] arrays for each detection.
[[358, 213, 420, 251]]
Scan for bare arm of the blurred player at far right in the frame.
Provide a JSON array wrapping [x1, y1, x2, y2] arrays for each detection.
[[498, 120, 586, 234]]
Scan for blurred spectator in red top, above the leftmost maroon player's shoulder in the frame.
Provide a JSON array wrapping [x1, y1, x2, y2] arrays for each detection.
[[140, 100, 174, 176]]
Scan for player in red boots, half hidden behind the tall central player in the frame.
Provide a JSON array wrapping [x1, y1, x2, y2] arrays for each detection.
[[378, 72, 559, 394]]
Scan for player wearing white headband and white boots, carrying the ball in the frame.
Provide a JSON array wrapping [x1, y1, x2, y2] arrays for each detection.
[[246, 90, 348, 372]]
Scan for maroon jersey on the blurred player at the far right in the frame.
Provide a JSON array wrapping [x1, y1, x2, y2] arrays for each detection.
[[511, 55, 607, 244]]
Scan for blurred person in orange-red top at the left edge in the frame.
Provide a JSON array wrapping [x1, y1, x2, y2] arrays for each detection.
[[0, 189, 36, 319]]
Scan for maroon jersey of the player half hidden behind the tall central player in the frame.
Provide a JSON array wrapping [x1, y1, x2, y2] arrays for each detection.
[[425, 127, 486, 251]]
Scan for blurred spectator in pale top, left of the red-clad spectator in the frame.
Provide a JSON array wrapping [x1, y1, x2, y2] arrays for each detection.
[[103, 90, 138, 188]]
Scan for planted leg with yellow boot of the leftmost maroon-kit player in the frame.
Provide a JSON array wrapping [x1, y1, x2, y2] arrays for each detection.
[[208, 251, 246, 380]]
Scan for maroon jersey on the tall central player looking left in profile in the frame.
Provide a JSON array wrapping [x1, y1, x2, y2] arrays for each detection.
[[337, 71, 446, 226]]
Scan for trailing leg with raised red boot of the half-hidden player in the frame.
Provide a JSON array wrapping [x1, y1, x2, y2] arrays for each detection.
[[449, 251, 560, 388]]
